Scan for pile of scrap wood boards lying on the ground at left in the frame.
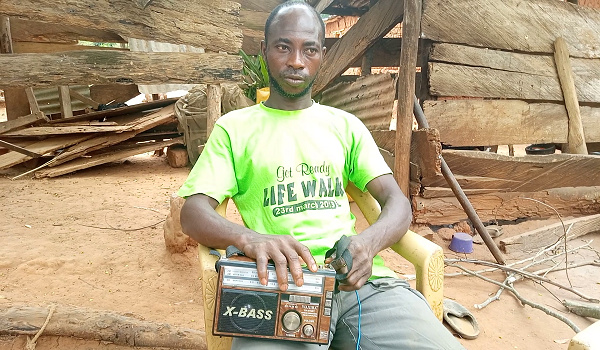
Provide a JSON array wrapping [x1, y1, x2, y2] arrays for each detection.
[[0, 99, 183, 177]]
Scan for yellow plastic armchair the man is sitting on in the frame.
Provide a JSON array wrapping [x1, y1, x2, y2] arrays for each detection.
[[198, 183, 444, 350]]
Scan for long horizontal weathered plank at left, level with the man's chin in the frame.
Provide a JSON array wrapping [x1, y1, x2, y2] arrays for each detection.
[[0, 50, 242, 87]]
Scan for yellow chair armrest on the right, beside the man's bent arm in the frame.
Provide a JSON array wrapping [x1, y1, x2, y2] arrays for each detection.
[[346, 182, 444, 321]]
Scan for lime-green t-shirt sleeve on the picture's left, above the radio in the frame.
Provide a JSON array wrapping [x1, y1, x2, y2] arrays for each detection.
[[177, 124, 238, 203]]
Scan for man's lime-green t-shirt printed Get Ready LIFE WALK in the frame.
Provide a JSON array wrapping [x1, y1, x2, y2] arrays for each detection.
[[178, 103, 395, 277]]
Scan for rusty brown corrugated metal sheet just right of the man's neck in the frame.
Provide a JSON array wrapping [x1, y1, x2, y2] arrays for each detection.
[[320, 74, 396, 130]]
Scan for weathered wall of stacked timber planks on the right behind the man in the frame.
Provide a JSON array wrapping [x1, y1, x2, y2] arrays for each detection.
[[376, 0, 600, 225]]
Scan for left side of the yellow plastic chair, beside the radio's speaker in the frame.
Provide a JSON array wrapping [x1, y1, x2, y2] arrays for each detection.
[[198, 198, 232, 350]]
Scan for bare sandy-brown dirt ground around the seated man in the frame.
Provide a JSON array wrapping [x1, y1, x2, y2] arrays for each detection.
[[0, 154, 600, 350]]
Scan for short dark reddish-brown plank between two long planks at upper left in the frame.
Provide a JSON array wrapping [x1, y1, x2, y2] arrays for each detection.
[[11, 18, 127, 44]]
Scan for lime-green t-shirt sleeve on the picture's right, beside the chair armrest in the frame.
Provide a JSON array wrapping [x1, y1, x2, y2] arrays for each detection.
[[349, 118, 392, 191]]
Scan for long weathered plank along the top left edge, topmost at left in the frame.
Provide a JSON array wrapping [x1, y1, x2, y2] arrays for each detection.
[[0, 0, 242, 53]]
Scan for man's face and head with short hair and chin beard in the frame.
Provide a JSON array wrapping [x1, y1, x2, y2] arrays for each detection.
[[262, 7, 325, 99]]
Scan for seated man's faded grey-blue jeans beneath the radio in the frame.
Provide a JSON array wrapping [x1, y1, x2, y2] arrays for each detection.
[[232, 278, 464, 350]]
